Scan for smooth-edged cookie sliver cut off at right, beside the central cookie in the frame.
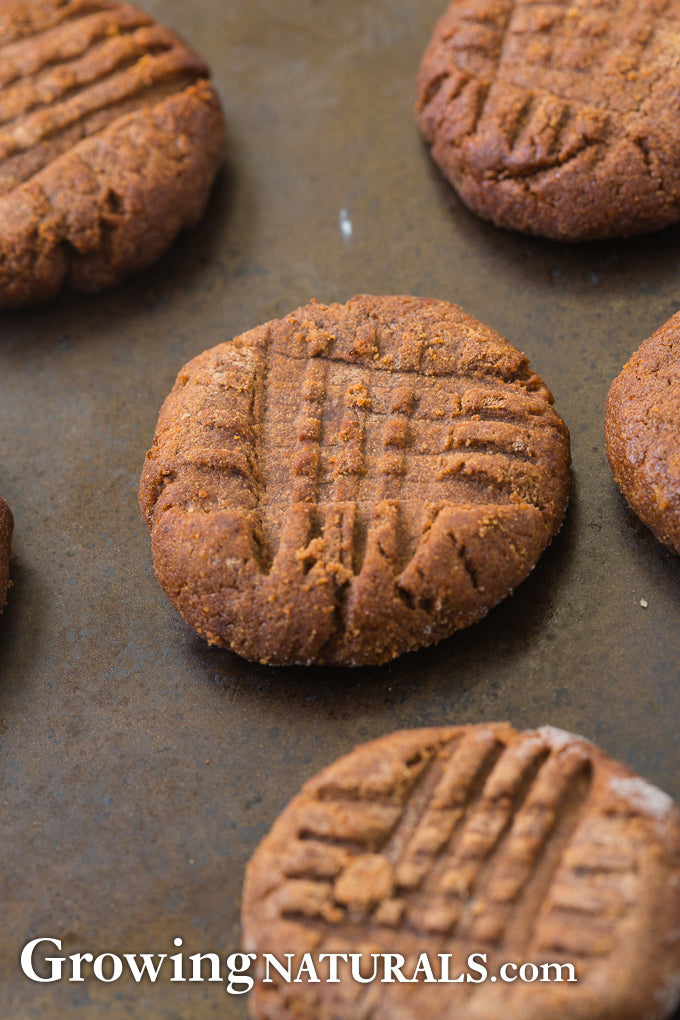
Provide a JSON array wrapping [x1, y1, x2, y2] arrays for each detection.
[[605, 312, 680, 554]]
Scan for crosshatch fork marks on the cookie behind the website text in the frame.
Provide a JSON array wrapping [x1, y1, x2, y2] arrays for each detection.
[[273, 729, 623, 953]]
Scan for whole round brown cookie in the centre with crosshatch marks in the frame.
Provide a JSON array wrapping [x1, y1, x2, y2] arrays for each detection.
[[140, 297, 569, 665]]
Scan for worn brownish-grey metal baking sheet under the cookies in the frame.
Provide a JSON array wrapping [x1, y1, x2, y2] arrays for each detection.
[[0, 0, 680, 1020]]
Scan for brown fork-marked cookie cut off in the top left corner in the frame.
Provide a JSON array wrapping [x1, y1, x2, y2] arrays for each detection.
[[0, 0, 224, 308]]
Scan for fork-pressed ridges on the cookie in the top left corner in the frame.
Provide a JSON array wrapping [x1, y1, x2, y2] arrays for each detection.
[[0, 4, 208, 194]]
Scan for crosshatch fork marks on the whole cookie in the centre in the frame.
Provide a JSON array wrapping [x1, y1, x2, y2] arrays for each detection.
[[247, 332, 566, 574]]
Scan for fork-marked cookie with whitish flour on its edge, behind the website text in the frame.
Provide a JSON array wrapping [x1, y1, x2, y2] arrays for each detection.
[[243, 724, 680, 1020]]
